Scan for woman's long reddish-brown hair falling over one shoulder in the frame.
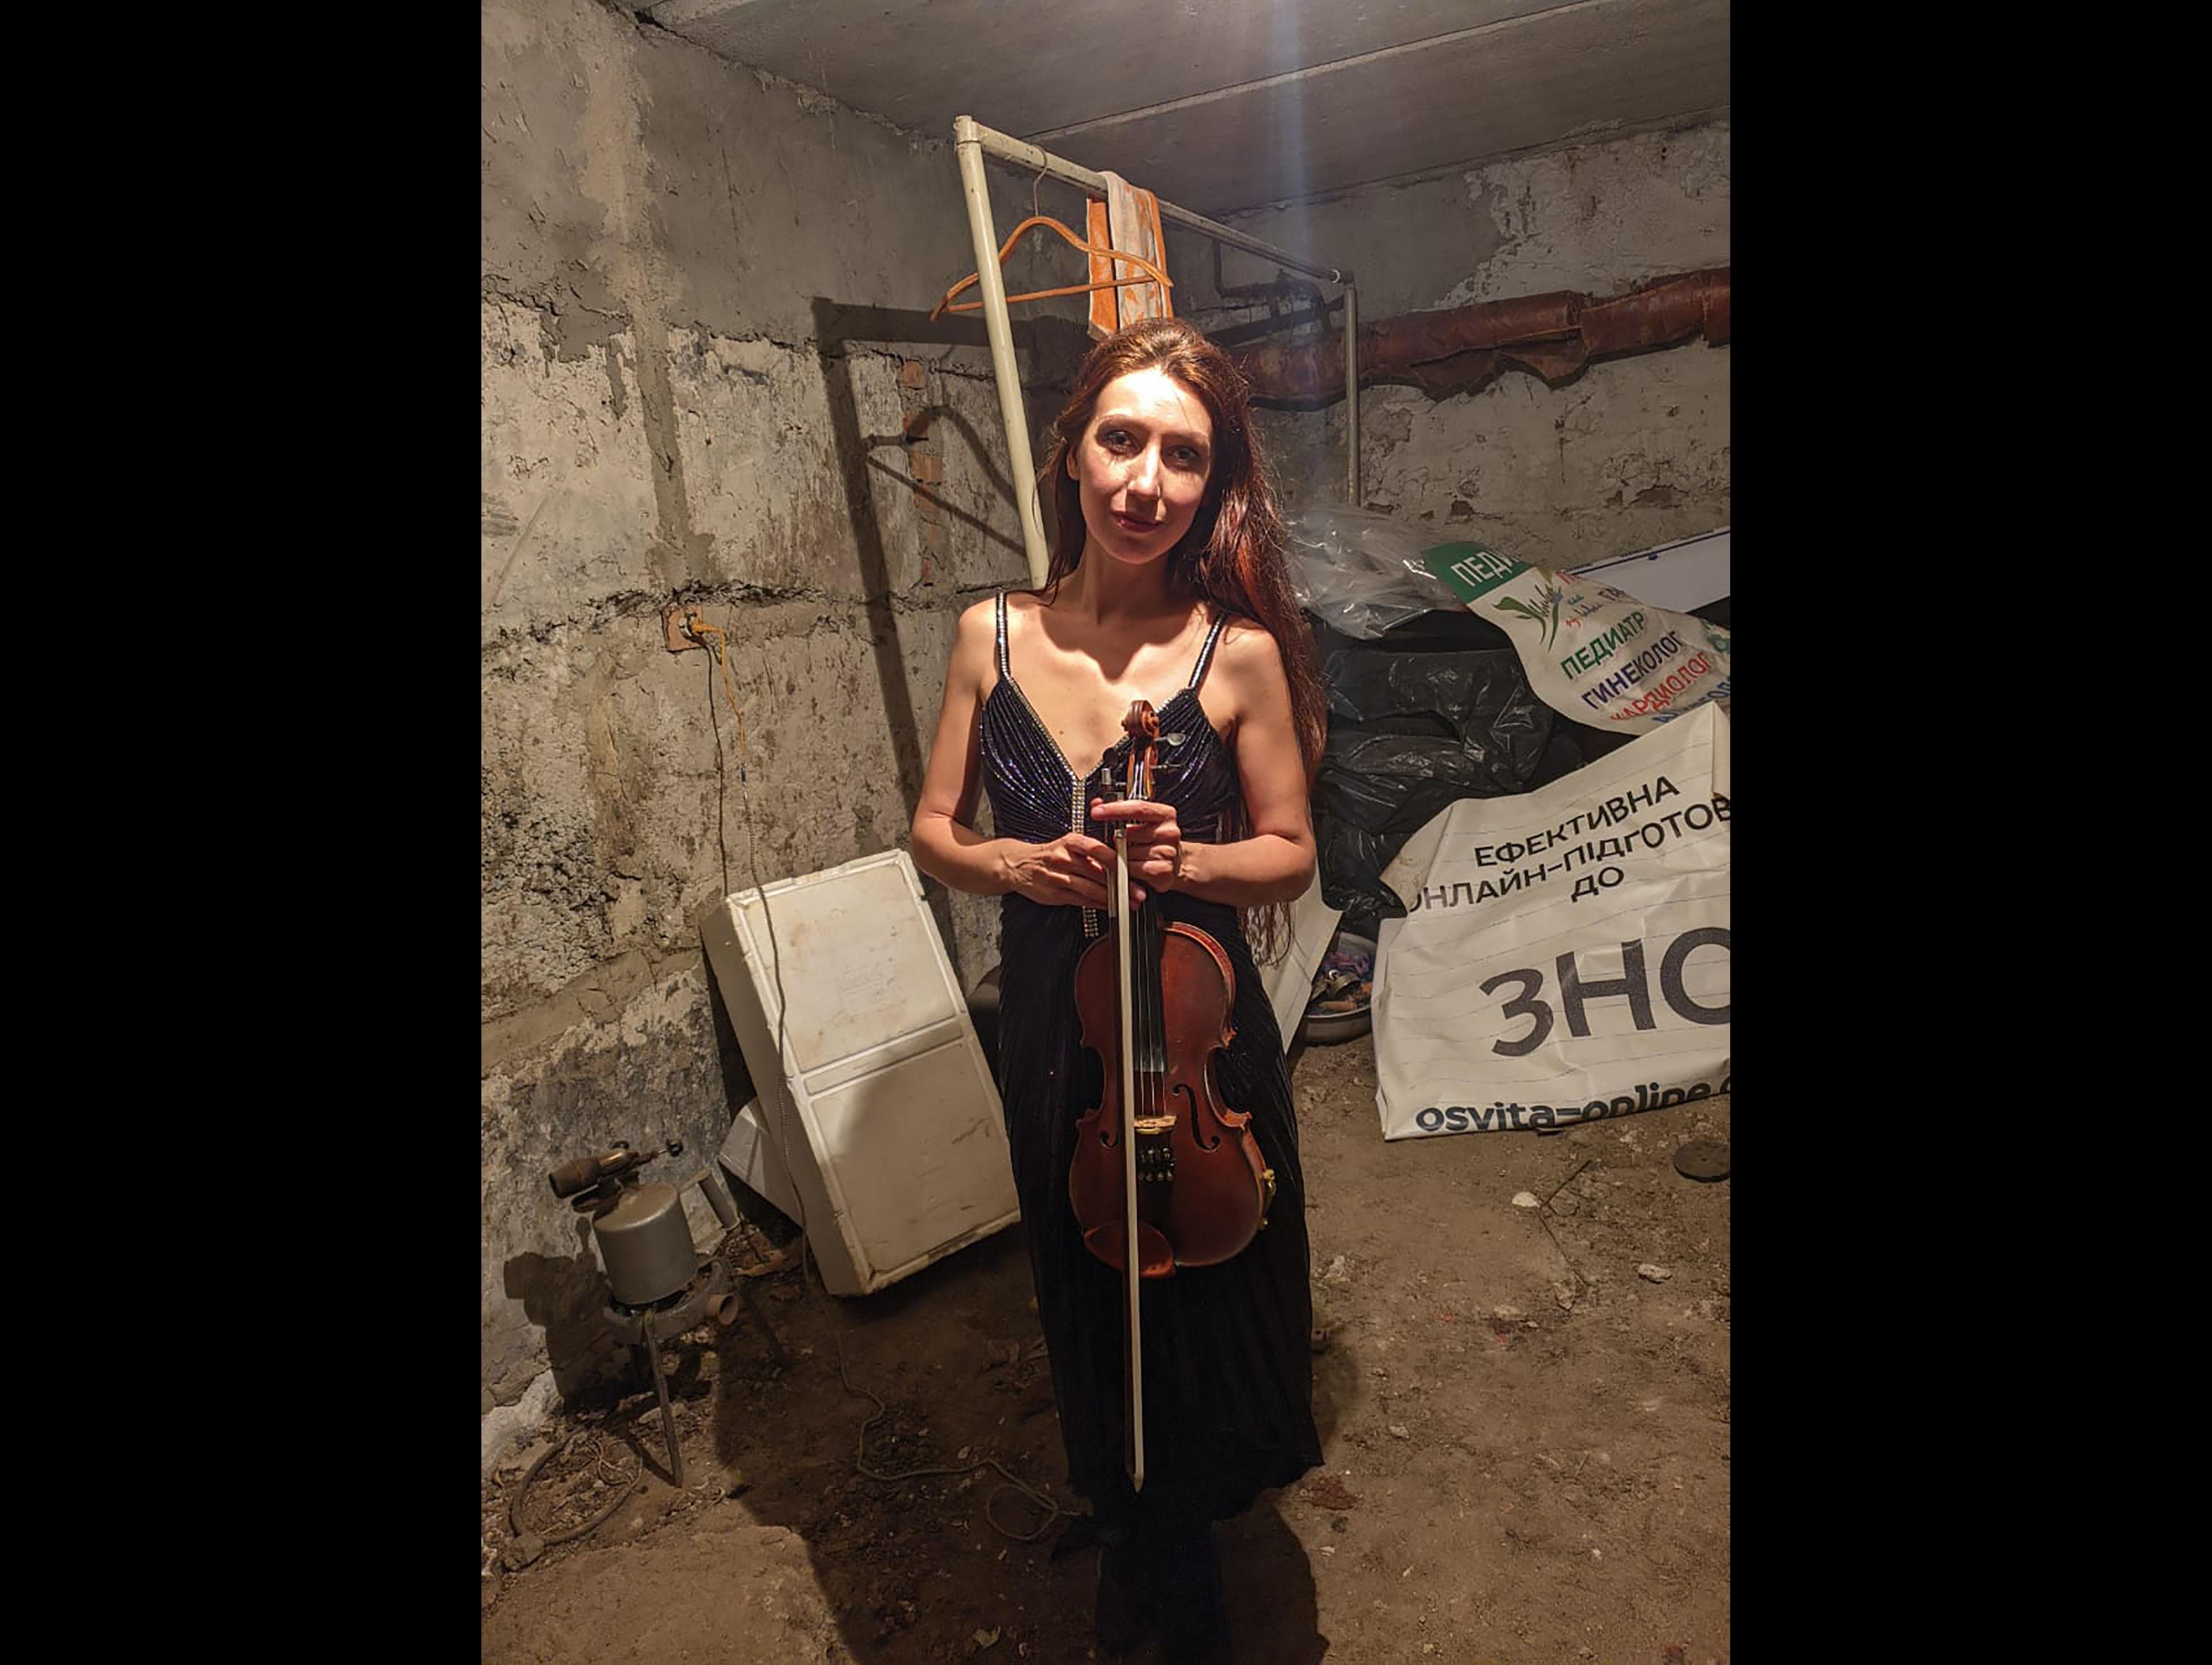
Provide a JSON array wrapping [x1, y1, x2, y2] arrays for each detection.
[[1038, 318, 1327, 960]]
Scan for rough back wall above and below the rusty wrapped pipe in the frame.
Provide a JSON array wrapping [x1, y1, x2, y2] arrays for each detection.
[[1192, 122, 1734, 566]]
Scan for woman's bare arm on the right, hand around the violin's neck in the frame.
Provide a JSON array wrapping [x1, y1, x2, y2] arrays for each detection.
[[1093, 624, 1314, 906]]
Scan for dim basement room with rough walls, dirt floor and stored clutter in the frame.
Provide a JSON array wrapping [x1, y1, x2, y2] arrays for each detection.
[[478, 0, 1732, 1665]]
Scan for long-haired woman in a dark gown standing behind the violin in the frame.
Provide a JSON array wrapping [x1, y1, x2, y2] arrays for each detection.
[[914, 318, 1325, 1658]]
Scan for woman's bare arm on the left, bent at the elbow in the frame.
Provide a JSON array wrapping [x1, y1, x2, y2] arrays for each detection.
[[914, 602, 1113, 906]]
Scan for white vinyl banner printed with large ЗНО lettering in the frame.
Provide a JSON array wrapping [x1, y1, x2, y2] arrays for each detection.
[[1374, 703, 1730, 1139]]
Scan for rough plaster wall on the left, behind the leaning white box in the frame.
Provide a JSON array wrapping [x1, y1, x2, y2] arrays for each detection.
[[480, 0, 1082, 1433]]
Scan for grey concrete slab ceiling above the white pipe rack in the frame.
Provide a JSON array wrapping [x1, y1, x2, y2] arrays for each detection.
[[646, 0, 1730, 214]]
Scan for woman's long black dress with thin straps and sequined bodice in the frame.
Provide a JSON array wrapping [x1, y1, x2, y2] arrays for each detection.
[[982, 595, 1320, 1521]]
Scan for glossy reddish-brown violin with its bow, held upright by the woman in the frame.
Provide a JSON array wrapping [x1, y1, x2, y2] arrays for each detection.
[[1069, 699, 1274, 1490]]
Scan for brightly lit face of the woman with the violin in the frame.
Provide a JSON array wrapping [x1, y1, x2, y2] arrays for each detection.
[[1069, 369, 1214, 566]]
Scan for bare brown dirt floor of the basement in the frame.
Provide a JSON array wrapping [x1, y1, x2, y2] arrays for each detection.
[[482, 1037, 1730, 1665]]
